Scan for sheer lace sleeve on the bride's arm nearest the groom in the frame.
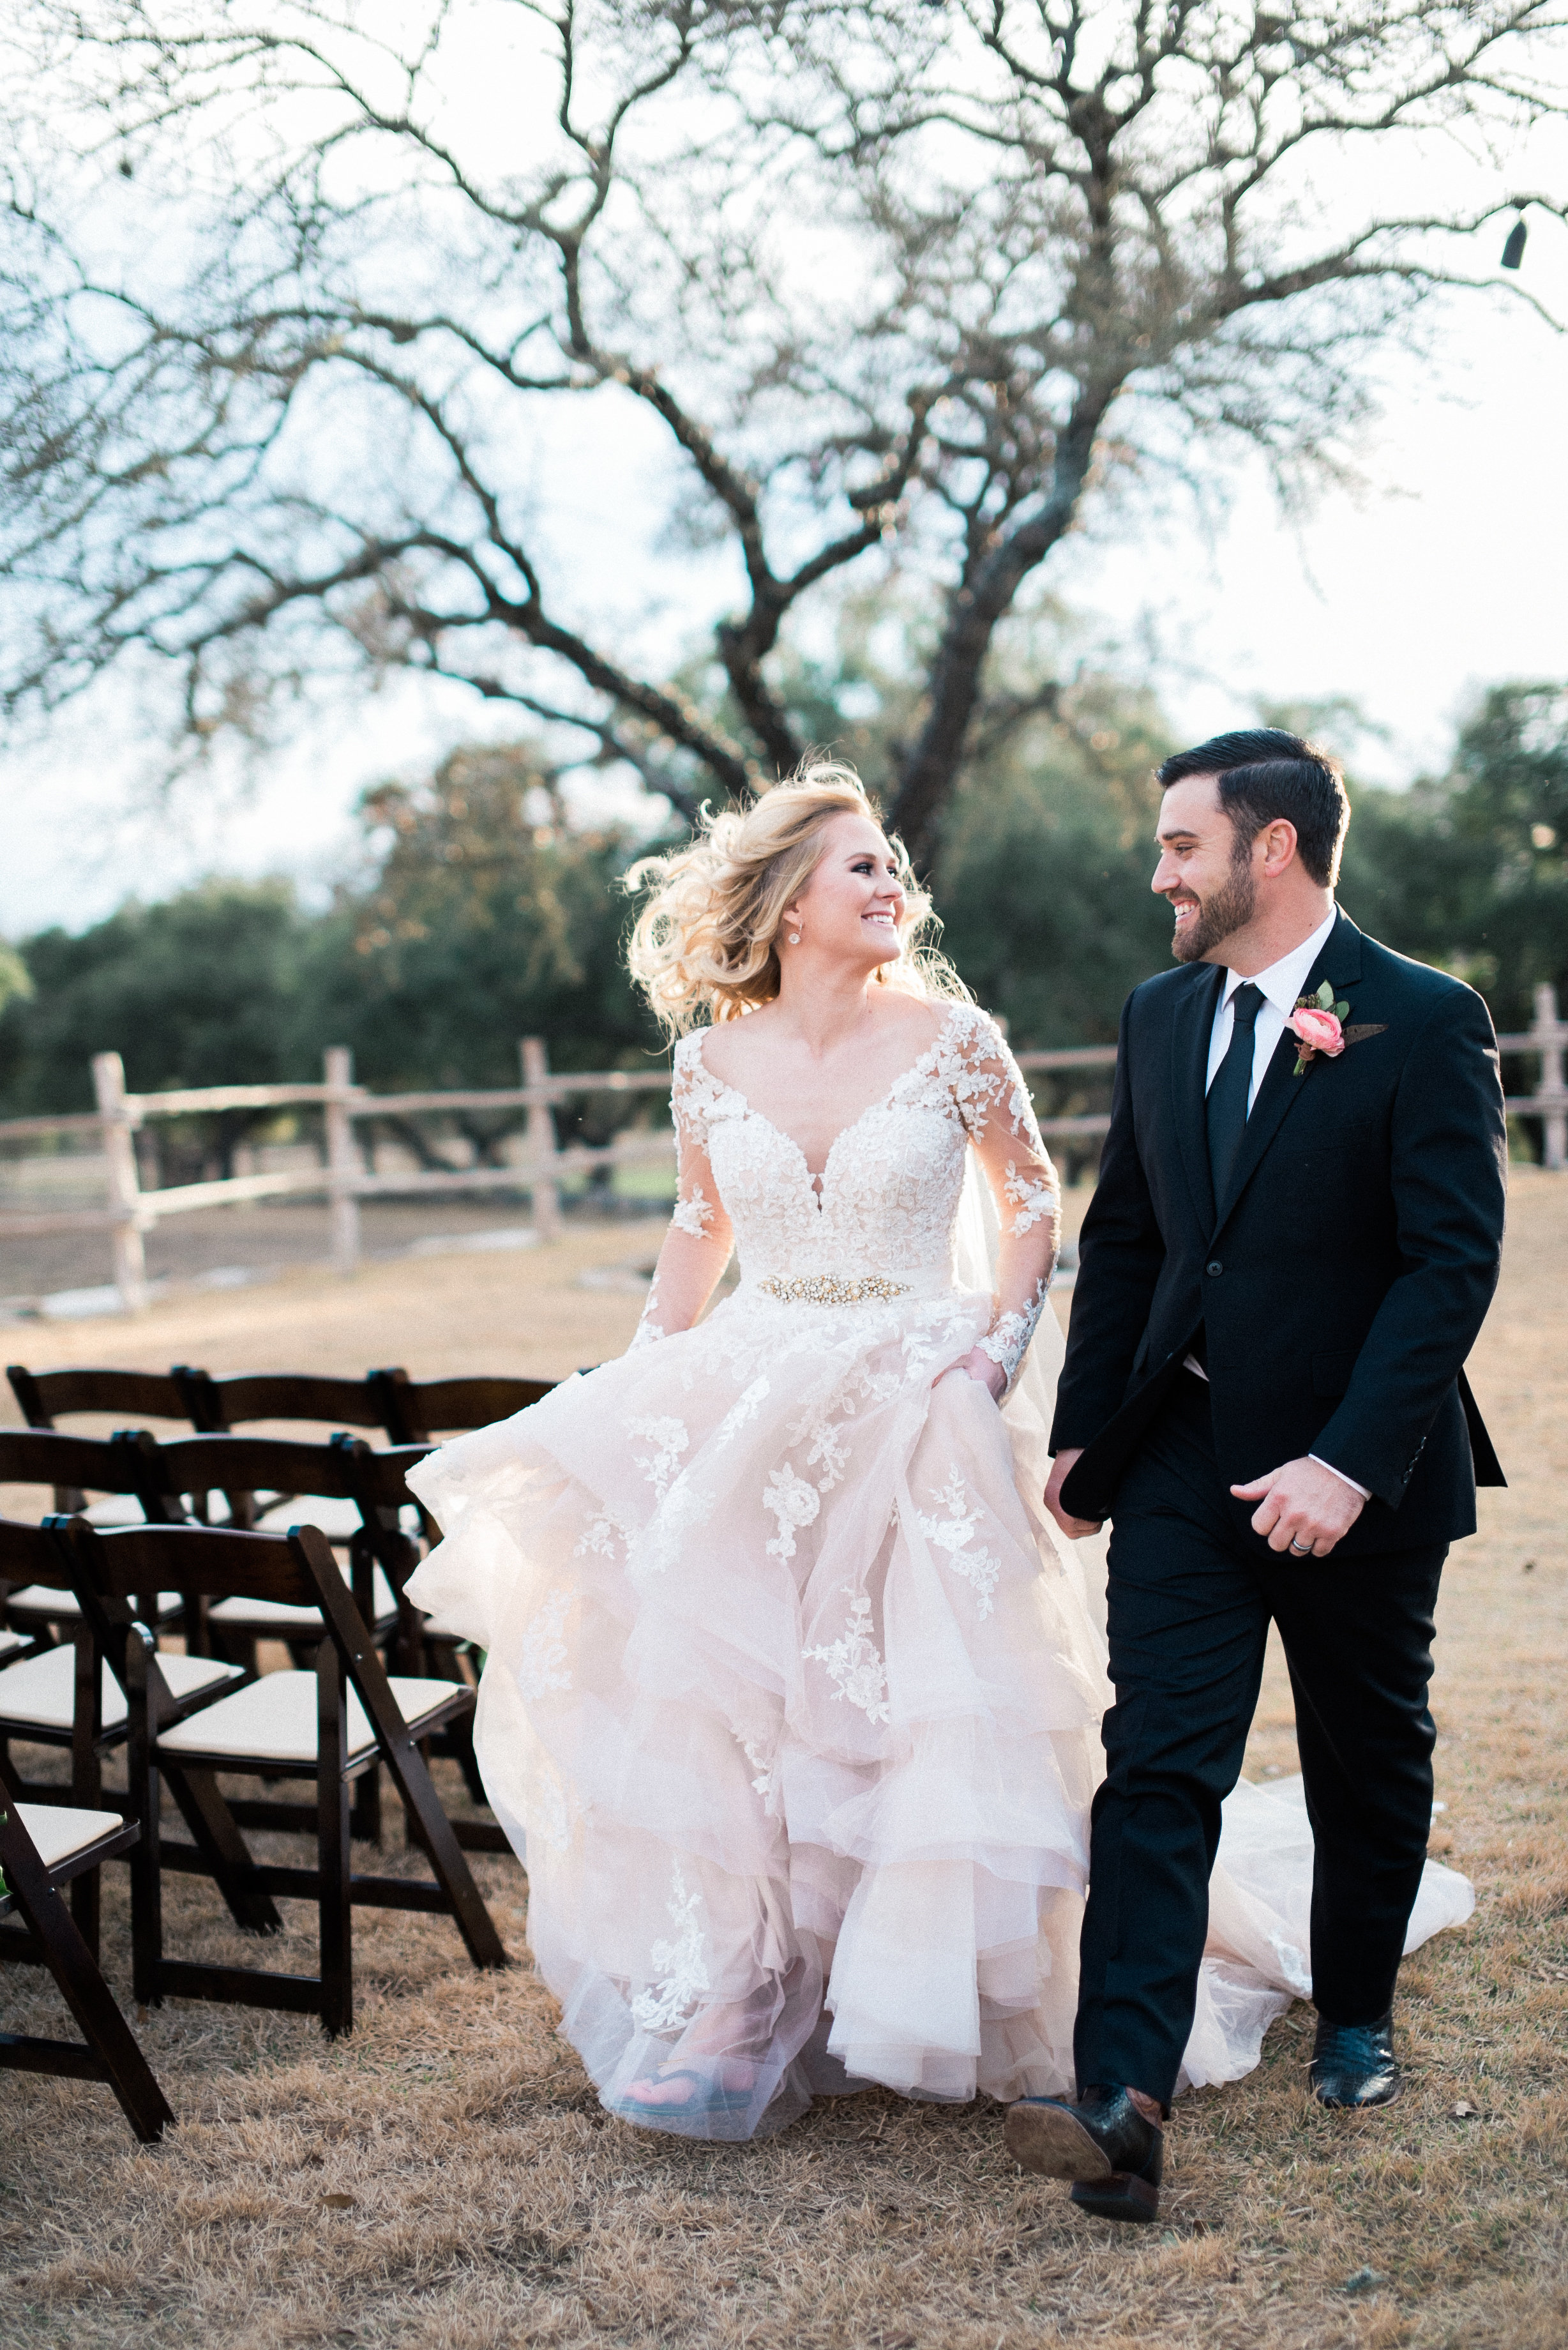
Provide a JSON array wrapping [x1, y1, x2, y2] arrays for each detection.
[[954, 1013, 1062, 1386]]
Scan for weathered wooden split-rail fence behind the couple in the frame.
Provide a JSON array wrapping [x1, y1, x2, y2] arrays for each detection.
[[0, 987, 1568, 1314]]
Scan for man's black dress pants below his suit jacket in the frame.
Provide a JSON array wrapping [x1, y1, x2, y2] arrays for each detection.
[[1074, 1372, 1448, 2101]]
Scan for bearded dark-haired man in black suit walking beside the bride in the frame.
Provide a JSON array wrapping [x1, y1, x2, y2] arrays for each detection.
[[1006, 729, 1507, 2221]]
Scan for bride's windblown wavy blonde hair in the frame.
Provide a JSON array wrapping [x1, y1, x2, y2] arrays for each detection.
[[625, 759, 969, 1036]]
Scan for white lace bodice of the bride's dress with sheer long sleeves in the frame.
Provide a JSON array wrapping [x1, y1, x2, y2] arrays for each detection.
[[640, 1003, 1058, 1377]]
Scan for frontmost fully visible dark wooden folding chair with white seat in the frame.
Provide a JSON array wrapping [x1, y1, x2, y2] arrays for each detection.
[[52, 1518, 508, 2035]]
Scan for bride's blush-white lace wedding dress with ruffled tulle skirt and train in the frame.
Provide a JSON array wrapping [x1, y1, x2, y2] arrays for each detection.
[[409, 1003, 1472, 2139]]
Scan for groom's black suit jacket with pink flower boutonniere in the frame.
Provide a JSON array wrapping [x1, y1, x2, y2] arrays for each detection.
[[1051, 914, 1507, 1556]]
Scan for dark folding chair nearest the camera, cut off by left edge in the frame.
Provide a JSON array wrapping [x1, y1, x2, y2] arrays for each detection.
[[0, 1796, 174, 2146]]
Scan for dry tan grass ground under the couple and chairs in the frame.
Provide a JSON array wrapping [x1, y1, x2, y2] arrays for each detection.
[[0, 1172, 1568, 2350]]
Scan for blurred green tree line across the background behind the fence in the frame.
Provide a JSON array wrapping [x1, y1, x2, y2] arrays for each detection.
[[0, 667, 1568, 1156]]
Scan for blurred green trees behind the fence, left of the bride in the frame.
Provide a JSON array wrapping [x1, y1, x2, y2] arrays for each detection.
[[0, 745, 658, 1172]]
